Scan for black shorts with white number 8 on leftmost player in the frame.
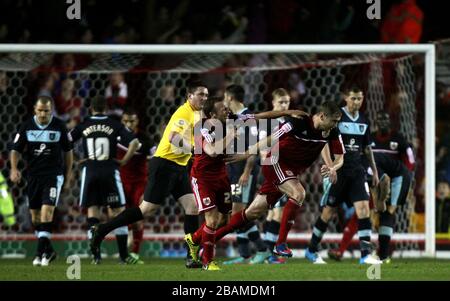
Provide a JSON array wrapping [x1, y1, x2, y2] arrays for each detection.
[[27, 175, 64, 209]]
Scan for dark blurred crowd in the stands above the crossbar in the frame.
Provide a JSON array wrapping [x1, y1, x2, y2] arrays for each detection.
[[0, 0, 448, 44]]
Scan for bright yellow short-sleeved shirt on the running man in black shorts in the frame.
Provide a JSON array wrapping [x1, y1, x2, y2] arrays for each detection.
[[155, 101, 200, 166]]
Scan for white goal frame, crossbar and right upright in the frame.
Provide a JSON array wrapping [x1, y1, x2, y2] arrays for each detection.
[[0, 44, 436, 257]]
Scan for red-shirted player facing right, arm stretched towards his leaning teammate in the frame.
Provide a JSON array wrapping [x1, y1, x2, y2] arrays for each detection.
[[185, 98, 305, 270]]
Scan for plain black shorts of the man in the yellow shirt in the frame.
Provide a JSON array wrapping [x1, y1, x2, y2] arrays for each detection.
[[144, 157, 192, 204]]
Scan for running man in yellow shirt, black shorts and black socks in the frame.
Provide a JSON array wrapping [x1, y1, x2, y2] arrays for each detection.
[[90, 82, 208, 268]]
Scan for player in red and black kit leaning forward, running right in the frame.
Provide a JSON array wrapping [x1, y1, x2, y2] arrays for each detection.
[[211, 101, 344, 248]]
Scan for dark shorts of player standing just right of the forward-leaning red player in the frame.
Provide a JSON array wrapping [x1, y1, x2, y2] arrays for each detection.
[[321, 168, 370, 207]]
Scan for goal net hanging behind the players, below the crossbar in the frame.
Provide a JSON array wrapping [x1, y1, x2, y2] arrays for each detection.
[[0, 46, 432, 255]]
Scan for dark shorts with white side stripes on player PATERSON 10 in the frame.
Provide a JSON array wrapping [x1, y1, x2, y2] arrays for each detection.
[[80, 167, 125, 208]]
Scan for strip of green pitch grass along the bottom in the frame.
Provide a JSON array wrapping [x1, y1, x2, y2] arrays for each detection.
[[0, 258, 450, 281]]
